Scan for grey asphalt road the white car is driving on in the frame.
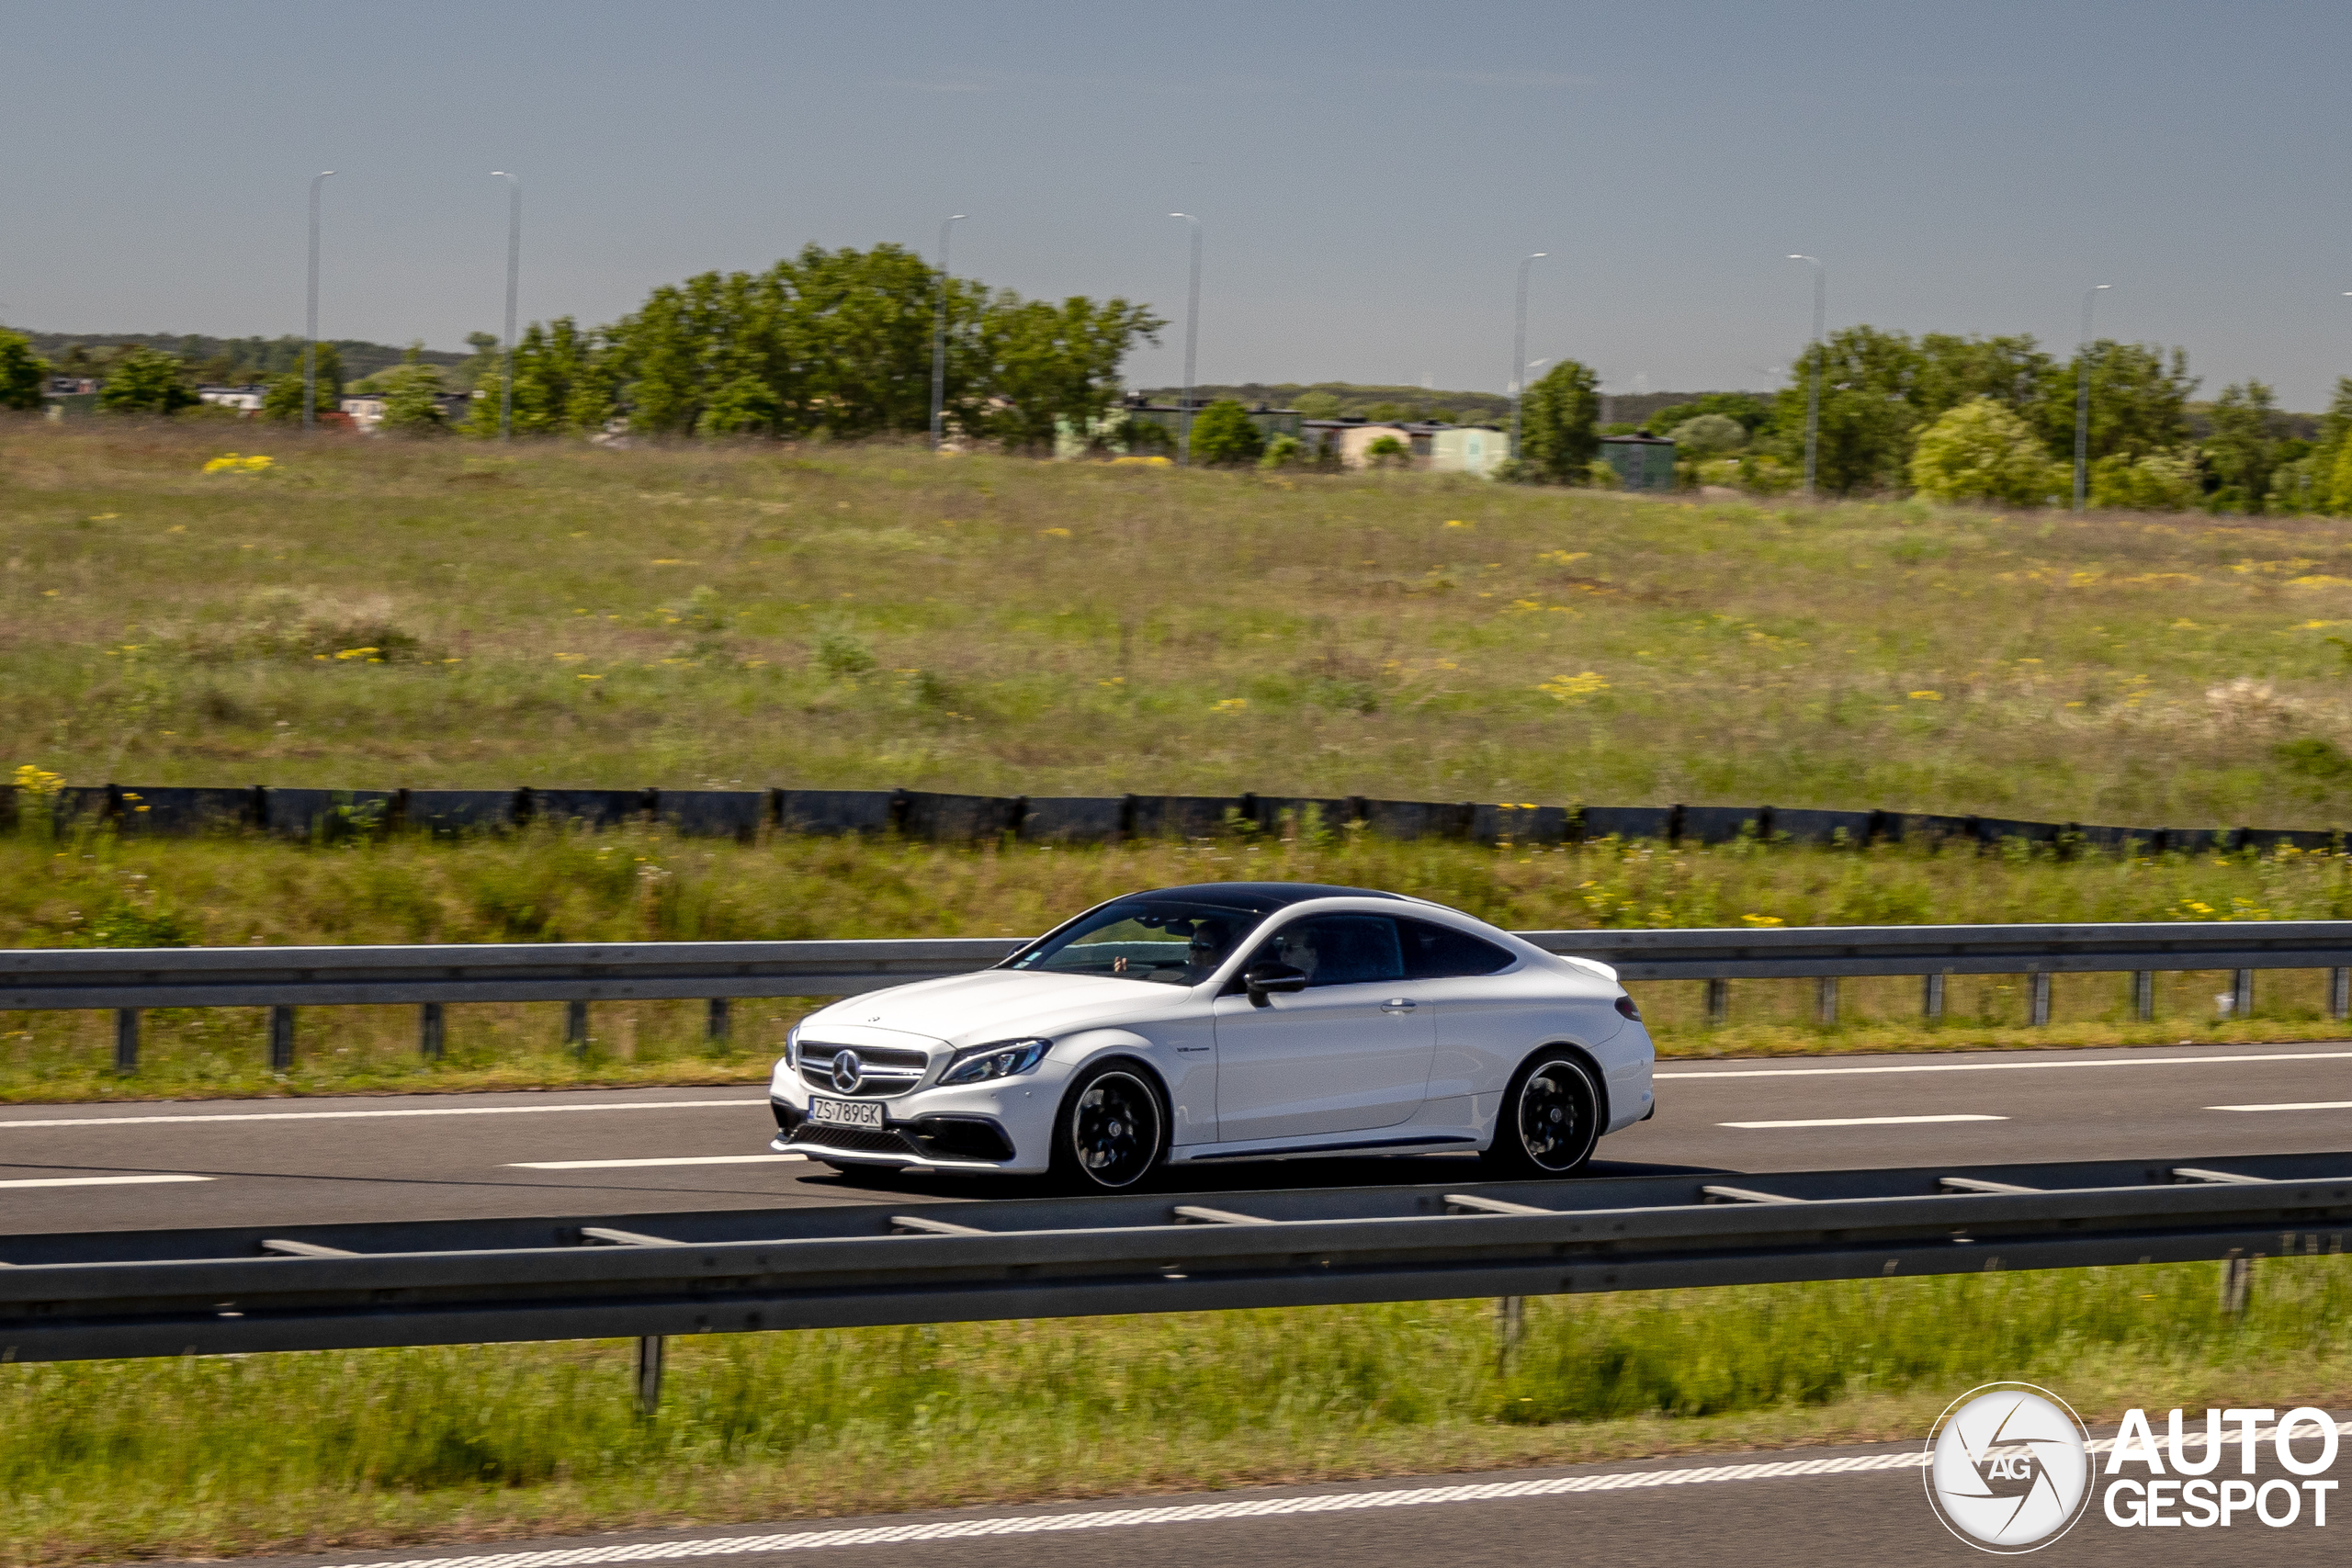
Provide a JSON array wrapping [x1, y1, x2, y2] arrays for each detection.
[[0, 1042, 2352, 1235]]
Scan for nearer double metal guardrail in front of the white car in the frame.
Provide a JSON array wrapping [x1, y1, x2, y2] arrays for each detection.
[[0, 1155, 2352, 1380]]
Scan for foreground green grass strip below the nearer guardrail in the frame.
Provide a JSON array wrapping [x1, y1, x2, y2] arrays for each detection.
[[0, 1258, 2352, 1563]]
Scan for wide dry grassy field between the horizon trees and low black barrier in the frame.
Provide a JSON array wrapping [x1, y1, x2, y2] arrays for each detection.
[[0, 423, 2352, 825]]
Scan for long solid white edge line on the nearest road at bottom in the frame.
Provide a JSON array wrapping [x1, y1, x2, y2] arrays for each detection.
[[303, 1453, 1928, 1568]]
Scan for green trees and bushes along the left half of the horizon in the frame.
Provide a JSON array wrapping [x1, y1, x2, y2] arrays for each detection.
[[0, 244, 1167, 451]]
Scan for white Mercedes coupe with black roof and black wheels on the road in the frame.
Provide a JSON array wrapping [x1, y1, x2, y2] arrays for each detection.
[[769, 882, 1656, 1192]]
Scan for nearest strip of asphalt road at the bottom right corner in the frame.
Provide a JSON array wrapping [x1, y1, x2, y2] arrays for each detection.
[[165, 1434, 2352, 1568]]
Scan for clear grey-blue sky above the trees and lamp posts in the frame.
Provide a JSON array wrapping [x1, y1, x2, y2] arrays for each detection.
[[0, 0, 2352, 409]]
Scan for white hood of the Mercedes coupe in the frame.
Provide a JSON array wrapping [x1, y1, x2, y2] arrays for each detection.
[[802, 968, 1193, 1046]]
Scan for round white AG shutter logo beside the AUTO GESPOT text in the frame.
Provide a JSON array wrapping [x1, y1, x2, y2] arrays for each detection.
[[1927, 1382, 2091, 1556]]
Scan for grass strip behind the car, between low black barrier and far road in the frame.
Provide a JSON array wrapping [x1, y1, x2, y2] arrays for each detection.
[[0, 829, 2352, 1100]]
